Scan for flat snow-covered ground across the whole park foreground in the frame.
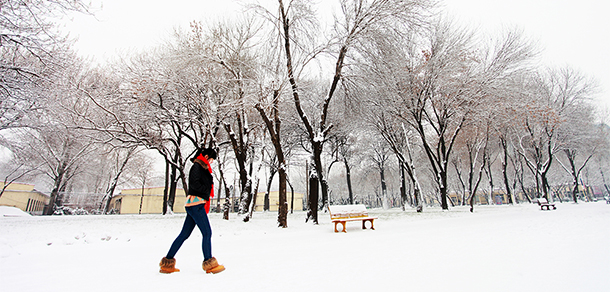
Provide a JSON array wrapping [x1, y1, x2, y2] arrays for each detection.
[[0, 202, 610, 292]]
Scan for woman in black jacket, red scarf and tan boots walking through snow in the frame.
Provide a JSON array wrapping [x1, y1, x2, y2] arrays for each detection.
[[159, 148, 225, 274]]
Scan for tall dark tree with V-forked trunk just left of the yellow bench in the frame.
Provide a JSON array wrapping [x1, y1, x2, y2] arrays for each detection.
[[269, 0, 429, 224]]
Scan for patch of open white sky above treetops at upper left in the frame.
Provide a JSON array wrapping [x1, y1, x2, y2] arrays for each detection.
[[66, 0, 240, 63]]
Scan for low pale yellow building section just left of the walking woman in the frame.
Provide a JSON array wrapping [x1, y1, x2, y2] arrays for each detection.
[[110, 187, 186, 214]]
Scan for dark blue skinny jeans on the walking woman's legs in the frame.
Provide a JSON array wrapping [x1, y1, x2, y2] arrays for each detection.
[[166, 204, 212, 260]]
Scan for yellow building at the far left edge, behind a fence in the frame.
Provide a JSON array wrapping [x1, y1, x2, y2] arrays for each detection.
[[0, 182, 50, 215]]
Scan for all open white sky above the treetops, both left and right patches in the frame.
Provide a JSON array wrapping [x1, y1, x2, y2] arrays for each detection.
[[66, 0, 610, 112]]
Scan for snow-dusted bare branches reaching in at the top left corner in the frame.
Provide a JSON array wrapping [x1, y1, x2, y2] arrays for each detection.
[[0, 0, 88, 130]]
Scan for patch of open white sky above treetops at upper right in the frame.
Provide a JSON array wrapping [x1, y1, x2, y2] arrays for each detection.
[[444, 0, 610, 113]]
